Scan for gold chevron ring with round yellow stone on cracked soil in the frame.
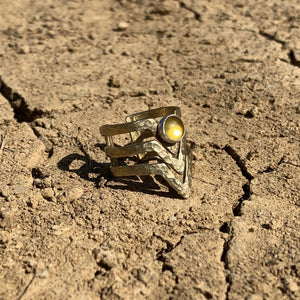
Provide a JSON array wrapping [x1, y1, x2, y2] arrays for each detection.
[[100, 106, 192, 198]]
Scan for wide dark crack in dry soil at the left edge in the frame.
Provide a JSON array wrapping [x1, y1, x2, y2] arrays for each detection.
[[0, 76, 45, 123]]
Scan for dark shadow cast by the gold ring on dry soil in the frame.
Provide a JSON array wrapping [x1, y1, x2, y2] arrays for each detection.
[[57, 143, 180, 198]]
